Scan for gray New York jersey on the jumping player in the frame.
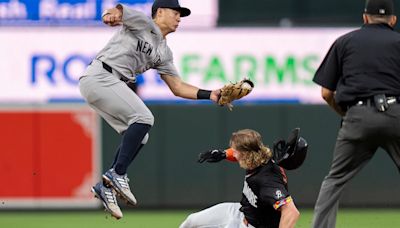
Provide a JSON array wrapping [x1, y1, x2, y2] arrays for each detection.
[[96, 5, 178, 79]]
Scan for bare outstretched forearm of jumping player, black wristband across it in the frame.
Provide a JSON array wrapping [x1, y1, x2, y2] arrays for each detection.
[[161, 74, 220, 102]]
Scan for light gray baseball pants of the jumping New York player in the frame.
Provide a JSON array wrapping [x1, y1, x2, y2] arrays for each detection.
[[79, 60, 154, 138]]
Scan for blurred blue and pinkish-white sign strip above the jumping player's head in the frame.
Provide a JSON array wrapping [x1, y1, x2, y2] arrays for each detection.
[[0, 0, 218, 28]]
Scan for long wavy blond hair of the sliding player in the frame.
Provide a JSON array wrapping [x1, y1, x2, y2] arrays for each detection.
[[230, 129, 272, 170]]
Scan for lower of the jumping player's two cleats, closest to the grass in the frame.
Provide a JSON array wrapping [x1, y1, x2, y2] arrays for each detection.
[[92, 182, 123, 219]]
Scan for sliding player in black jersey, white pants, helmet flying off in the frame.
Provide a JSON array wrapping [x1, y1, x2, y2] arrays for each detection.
[[180, 129, 307, 228]]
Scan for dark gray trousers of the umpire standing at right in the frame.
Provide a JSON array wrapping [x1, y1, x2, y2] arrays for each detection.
[[312, 104, 400, 228]]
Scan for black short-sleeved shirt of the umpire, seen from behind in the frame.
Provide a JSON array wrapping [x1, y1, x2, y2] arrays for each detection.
[[313, 24, 400, 105]]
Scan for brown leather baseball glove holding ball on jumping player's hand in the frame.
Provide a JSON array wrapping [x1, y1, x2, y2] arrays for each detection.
[[218, 78, 254, 111]]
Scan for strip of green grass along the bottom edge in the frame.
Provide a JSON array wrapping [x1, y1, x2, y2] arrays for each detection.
[[0, 209, 400, 228]]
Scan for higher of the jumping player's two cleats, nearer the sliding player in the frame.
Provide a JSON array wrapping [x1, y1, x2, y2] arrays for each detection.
[[103, 169, 137, 206]]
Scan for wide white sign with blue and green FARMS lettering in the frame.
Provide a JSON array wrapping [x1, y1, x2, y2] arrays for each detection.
[[0, 27, 350, 103]]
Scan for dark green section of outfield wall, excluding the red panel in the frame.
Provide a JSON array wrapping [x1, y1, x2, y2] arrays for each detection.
[[102, 105, 400, 207]]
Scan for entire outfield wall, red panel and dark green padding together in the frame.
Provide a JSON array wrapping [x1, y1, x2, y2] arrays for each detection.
[[0, 104, 400, 210]]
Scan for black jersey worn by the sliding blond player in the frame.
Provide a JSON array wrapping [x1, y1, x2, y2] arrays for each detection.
[[240, 160, 292, 228]]
